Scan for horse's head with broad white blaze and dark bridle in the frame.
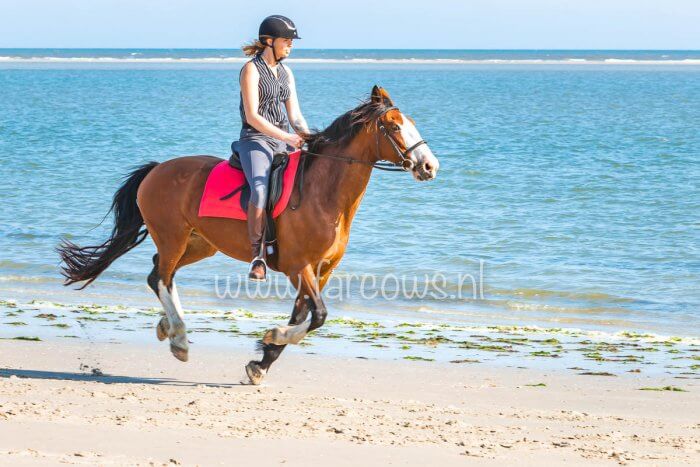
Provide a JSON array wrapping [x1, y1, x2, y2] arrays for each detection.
[[372, 86, 440, 181]]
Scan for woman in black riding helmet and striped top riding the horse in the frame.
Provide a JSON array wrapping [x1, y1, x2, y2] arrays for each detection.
[[231, 15, 309, 281]]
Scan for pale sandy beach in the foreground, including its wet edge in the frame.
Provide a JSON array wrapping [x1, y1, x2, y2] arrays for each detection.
[[0, 302, 700, 465]]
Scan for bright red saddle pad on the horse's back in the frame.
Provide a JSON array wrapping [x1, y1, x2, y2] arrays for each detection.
[[199, 151, 301, 220]]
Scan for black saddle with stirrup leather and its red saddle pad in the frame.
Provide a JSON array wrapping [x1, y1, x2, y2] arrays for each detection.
[[198, 146, 302, 264]]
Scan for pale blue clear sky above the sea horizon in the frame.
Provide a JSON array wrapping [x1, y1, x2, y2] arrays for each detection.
[[0, 0, 700, 50]]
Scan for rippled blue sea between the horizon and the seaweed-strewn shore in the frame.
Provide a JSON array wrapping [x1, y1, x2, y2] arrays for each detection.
[[0, 49, 700, 336]]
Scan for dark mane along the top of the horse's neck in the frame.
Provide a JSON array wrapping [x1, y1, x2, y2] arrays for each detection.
[[306, 100, 387, 167]]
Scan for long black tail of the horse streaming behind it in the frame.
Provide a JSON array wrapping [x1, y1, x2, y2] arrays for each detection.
[[56, 162, 158, 289]]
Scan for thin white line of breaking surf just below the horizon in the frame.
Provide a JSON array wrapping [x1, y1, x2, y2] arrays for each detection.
[[0, 54, 700, 66]]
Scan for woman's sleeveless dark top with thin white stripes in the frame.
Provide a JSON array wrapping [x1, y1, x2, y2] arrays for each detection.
[[239, 54, 290, 135]]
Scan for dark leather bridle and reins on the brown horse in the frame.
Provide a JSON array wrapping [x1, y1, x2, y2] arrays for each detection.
[[289, 106, 428, 211]]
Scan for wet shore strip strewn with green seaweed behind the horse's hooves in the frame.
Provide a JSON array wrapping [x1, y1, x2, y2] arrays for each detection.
[[0, 299, 700, 386]]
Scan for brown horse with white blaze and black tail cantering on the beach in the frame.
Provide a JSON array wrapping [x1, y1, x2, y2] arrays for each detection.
[[58, 86, 439, 384]]
